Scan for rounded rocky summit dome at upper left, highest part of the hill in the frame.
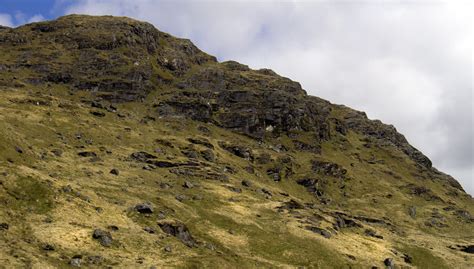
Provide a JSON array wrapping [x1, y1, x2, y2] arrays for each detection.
[[0, 15, 216, 102]]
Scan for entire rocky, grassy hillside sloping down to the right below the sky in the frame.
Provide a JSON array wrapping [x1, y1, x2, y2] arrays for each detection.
[[0, 15, 474, 268]]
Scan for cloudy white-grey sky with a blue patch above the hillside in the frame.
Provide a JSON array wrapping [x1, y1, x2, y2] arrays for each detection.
[[0, 0, 474, 195]]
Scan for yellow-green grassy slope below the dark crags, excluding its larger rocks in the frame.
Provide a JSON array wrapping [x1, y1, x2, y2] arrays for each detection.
[[0, 86, 474, 268]]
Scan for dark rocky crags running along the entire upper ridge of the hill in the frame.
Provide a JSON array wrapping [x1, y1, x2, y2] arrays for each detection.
[[0, 15, 462, 190]]
